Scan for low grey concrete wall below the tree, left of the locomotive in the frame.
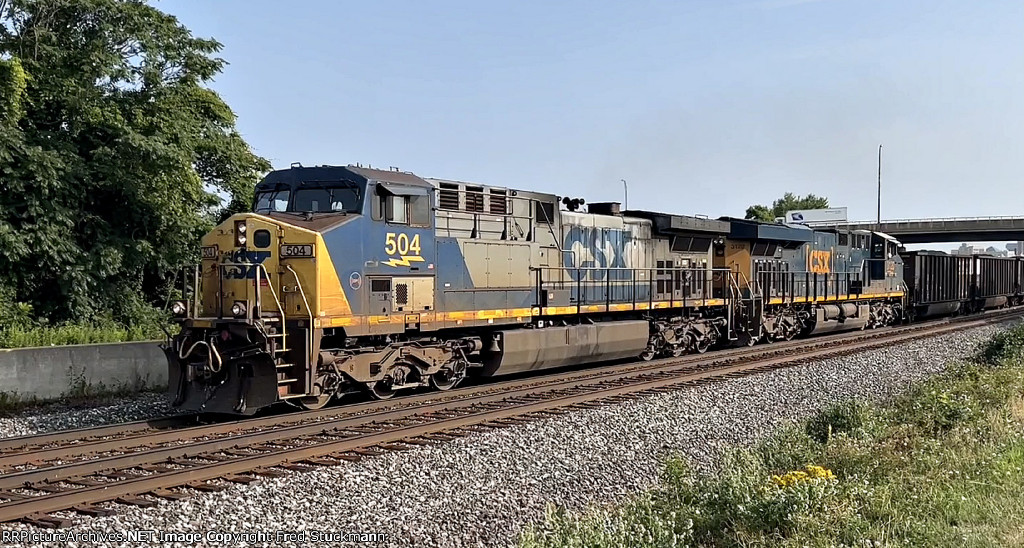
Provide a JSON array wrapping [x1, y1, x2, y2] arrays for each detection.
[[0, 342, 167, 402]]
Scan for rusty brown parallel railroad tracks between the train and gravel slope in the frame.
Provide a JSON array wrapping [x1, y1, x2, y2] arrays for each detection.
[[0, 310, 1024, 526]]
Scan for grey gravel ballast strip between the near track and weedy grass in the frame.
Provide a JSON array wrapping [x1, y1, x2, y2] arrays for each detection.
[[0, 325, 1006, 547]]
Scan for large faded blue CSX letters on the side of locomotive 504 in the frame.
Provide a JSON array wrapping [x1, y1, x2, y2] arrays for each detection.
[[562, 226, 633, 281]]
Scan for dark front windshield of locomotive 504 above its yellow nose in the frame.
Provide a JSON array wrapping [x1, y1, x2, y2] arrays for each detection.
[[255, 181, 362, 213]]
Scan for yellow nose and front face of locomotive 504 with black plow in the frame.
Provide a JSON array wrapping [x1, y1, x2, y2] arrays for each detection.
[[165, 167, 367, 414]]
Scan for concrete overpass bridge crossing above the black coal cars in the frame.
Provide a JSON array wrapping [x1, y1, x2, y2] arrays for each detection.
[[808, 216, 1024, 244]]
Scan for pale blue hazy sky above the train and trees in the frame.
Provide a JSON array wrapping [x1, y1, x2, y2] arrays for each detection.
[[155, 0, 1024, 239]]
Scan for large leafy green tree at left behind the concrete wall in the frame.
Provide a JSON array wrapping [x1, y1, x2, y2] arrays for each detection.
[[0, 0, 269, 323]]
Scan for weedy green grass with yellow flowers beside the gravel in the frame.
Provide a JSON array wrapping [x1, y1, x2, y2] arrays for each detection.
[[520, 327, 1024, 548]]
